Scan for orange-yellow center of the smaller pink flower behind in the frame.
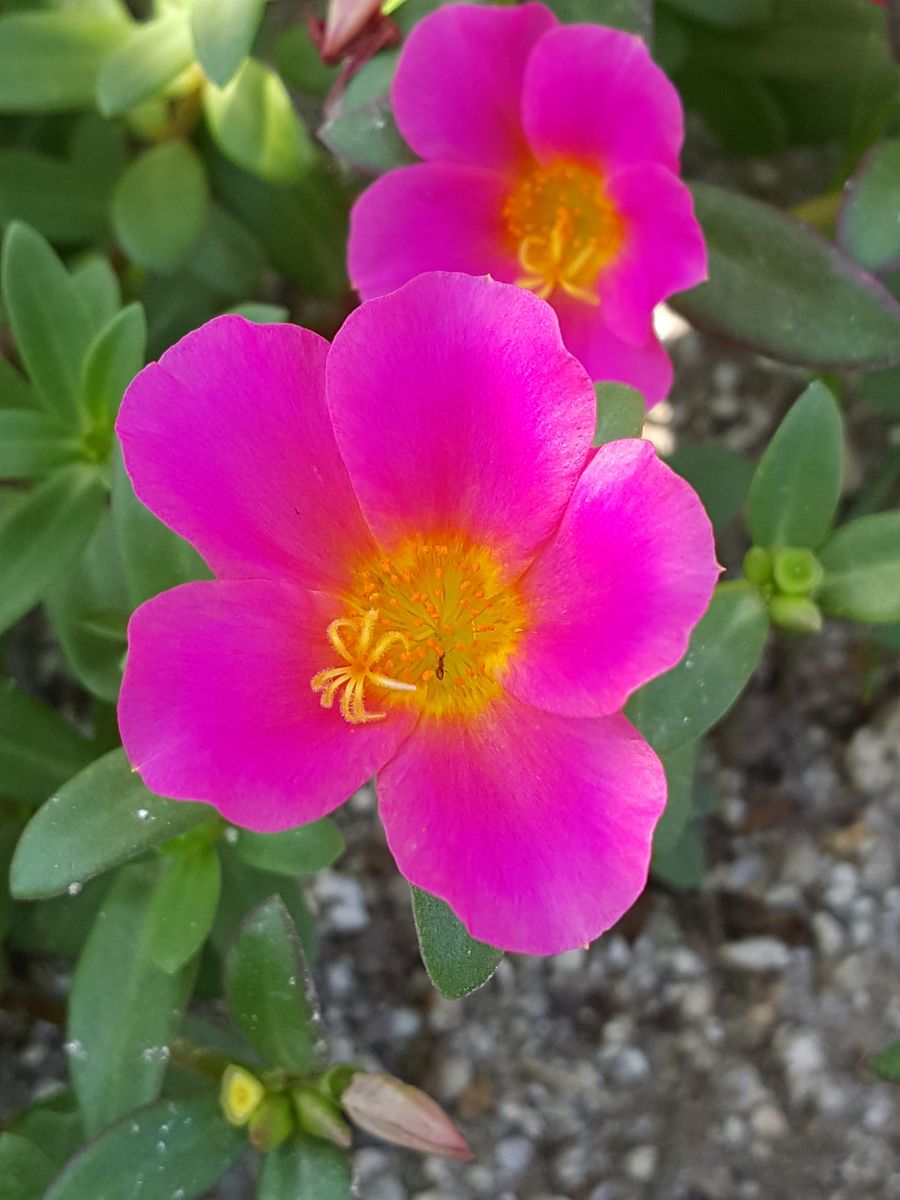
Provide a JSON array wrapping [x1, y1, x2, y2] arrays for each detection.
[[503, 160, 623, 305]]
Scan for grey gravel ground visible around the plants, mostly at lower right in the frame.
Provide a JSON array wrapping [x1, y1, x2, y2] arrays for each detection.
[[0, 150, 900, 1200]]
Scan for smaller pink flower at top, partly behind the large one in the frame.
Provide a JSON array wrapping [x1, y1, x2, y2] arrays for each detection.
[[349, 4, 706, 403]]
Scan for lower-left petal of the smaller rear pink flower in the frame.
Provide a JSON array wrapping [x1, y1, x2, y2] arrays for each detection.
[[348, 163, 521, 300]]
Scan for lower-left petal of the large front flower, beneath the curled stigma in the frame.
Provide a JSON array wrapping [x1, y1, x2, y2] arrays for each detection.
[[119, 580, 414, 832]]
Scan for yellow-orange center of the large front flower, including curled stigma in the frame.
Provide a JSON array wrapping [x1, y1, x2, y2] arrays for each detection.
[[310, 538, 524, 725]]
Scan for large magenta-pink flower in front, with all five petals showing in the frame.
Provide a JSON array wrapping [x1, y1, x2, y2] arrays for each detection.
[[118, 274, 716, 954]]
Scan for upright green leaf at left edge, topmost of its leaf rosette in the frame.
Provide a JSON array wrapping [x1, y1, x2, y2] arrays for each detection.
[[2, 221, 94, 427]]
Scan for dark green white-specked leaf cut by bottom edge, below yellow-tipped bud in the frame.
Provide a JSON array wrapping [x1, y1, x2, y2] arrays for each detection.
[[43, 1094, 247, 1200]]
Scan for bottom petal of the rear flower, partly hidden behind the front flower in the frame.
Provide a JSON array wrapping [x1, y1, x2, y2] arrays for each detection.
[[553, 293, 672, 408]]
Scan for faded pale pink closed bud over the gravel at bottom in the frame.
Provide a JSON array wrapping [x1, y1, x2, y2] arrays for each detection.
[[341, 1072, 472, 1163]]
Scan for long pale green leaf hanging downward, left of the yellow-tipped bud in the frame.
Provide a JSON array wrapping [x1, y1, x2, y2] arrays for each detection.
[[67, 862, 193, 1135]]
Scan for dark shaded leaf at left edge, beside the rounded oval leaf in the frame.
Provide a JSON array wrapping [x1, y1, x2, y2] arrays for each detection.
[[0, 146, 113, 245]]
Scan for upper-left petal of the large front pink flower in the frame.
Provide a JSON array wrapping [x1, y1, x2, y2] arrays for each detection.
[[116, 317, 372, 587]]
